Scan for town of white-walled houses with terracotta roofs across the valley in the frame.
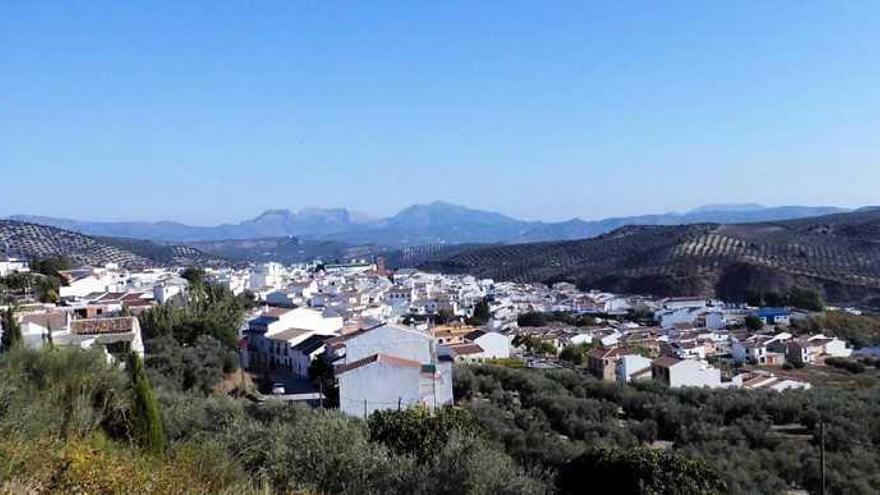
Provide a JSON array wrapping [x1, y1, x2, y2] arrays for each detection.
[[0, 254, 872, 416]]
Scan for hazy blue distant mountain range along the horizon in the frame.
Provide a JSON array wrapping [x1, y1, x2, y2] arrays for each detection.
[[10, 201, 847, 247]]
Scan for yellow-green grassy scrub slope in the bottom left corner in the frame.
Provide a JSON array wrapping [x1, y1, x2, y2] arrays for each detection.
[[0, 349, 254, 493]]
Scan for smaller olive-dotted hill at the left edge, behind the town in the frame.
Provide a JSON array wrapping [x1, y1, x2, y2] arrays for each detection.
[[0, 220, 225, 268]]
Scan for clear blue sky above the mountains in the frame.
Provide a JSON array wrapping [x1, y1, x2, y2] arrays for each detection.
[[0, 0, 880, 224]]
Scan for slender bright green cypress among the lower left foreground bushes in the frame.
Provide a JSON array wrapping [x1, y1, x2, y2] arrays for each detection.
[[128, 352, 167, 454]]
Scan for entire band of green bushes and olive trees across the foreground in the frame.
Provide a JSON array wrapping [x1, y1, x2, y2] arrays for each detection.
[[12, 349, 880, 495]]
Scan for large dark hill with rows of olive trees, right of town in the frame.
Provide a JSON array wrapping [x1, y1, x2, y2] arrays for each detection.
[[420, 208, 880, 305]]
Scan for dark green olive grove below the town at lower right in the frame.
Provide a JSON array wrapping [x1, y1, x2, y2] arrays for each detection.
[[456, 366, 880, 494]]
